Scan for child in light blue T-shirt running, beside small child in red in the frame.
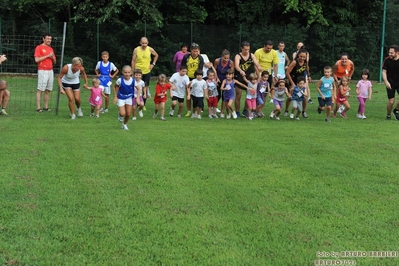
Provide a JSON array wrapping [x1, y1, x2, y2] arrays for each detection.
[[316, 66, 336, 122]]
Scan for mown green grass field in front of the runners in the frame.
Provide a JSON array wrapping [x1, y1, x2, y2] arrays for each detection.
[[0, 78, 399, 265]]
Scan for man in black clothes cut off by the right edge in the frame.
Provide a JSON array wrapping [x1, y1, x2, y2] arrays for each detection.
[[382, 45, 399, 120]]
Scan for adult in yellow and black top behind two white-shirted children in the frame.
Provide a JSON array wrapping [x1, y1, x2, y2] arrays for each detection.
[[181, 42, 204, 117]]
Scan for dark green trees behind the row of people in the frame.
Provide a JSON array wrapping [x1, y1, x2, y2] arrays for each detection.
[[0, 0, 399, 78]]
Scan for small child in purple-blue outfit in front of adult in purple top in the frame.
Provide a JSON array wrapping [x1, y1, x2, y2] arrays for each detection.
[[220, 69, 248, 119]]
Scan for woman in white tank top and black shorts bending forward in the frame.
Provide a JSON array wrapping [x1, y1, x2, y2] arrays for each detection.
[[58, 57, 88, 119]]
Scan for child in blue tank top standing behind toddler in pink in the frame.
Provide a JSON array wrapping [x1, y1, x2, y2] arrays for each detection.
[[94, 51, 119, 113]]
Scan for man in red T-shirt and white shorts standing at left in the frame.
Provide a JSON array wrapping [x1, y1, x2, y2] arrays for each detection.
[[33, 33, 56, 113]]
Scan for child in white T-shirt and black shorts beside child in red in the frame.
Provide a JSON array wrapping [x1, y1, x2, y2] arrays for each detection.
[[169, 65, 190, 118]]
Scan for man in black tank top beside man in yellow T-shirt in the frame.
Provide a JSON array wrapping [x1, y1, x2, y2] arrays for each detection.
[[234, 41, 262, 117]]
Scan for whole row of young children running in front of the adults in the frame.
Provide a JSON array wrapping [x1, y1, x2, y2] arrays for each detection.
[[85, 52, 372, 130]]
